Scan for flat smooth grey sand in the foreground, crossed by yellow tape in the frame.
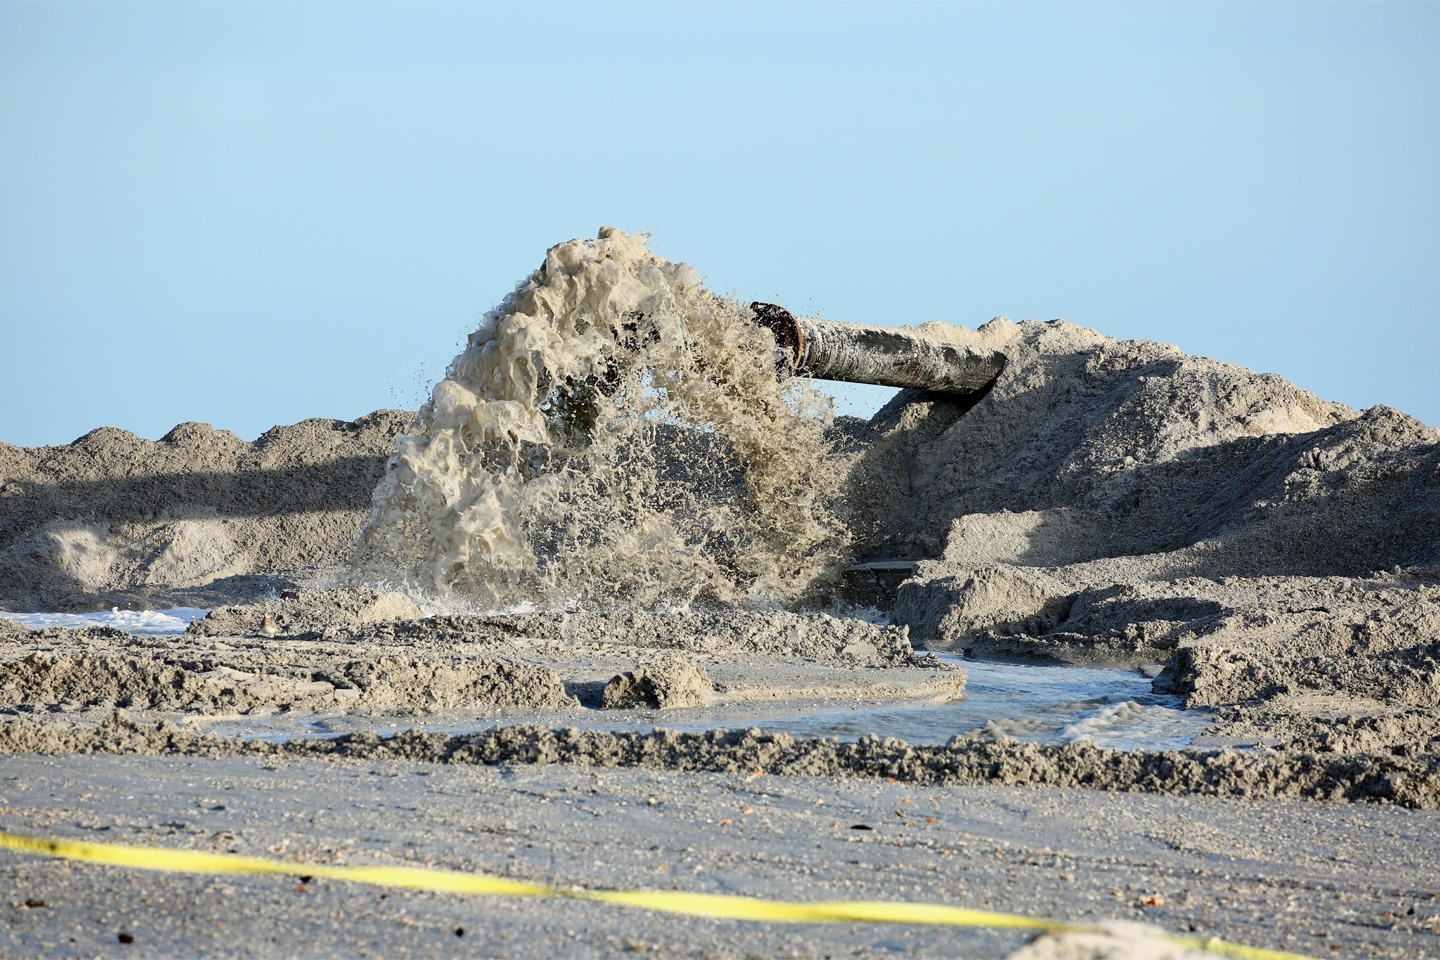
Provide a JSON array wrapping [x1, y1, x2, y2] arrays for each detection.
[[0, 756, 1440, 957]]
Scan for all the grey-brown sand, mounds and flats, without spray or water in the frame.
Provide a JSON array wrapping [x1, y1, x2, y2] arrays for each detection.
[[0, 269, 1440, 957]]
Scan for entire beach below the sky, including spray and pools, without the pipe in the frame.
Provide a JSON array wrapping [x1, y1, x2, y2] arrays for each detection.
[[0, 229, 1440, 960]]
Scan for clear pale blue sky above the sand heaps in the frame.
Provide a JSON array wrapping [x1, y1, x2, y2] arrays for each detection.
[[0, 3, 1440, 445]]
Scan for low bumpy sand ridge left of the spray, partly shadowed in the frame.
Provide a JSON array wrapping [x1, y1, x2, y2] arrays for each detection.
[[0, 410, 410, 610]]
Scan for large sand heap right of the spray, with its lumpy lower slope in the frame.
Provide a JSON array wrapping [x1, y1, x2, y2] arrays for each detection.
[[850, 320, 1440, 725]]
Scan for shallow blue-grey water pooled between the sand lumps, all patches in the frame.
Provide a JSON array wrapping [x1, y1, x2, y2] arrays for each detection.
[[8, 607, 1210, 750]]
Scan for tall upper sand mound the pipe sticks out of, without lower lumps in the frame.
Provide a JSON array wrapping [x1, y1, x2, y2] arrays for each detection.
[[851, 320, 1440, 579]]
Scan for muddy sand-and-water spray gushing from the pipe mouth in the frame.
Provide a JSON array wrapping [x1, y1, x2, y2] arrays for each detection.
[[354, 229, 847, 604]]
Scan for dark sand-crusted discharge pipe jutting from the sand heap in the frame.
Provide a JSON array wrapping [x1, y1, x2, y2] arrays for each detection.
[[750, 304, 1005, 393]]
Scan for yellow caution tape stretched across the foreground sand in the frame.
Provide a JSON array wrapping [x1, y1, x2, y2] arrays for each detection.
[[0, 833, 1313, 960]]
